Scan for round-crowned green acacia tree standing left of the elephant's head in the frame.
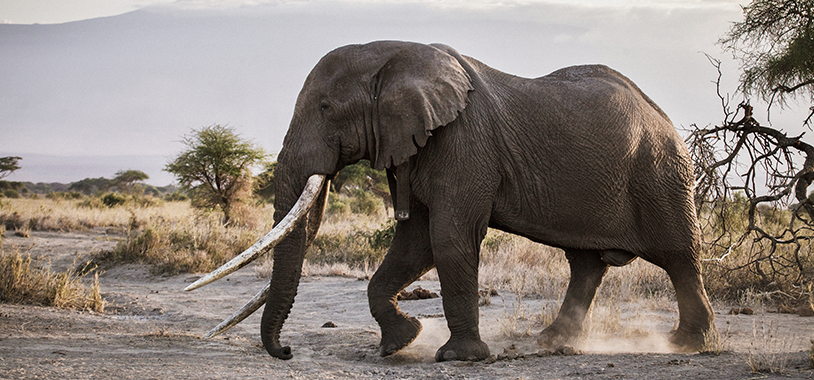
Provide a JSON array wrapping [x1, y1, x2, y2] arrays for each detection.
[[164, 124, 267, 224]]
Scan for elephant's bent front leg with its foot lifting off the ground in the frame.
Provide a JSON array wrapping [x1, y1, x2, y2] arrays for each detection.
[[368, 200, 433, 356]]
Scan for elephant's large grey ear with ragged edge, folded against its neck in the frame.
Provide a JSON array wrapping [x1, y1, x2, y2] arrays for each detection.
[[373, 44, 474, 170]]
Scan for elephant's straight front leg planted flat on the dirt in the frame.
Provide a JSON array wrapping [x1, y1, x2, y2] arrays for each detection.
[[433, 215, 490, 362]]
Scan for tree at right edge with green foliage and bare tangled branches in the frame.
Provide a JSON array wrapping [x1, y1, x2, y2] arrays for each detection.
[[687, 0, 814, 298]]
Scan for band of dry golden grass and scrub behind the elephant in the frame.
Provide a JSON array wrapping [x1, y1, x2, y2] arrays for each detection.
[[0, 184, 814, 307]]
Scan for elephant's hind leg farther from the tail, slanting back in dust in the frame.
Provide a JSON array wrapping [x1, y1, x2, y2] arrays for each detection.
[[537, 249, 608, 348]]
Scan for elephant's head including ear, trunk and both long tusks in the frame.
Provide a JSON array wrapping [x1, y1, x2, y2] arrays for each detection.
[[187, 41, 473, 359]]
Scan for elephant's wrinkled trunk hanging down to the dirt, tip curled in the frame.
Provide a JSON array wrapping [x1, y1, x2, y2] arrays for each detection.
[[260, 165, 329, 359]]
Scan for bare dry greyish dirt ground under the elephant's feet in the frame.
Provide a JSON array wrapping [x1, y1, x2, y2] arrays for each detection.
[[0, 230, 814, 380]]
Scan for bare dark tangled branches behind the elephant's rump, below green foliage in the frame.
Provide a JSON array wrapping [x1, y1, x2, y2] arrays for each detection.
[[687, 57, 814, 290]]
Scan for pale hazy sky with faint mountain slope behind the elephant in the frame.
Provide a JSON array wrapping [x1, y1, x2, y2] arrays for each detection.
[[0, 0, 804, 185]]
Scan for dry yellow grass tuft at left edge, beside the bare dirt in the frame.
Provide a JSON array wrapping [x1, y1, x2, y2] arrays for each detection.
[[0, 249, 105, 312]]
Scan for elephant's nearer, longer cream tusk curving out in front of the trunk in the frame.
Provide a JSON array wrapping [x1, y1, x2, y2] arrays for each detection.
[[184, 174, 325, 291]]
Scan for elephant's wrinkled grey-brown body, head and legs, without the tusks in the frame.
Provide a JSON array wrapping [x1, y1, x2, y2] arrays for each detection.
[[261, 41, 713, 361]]
